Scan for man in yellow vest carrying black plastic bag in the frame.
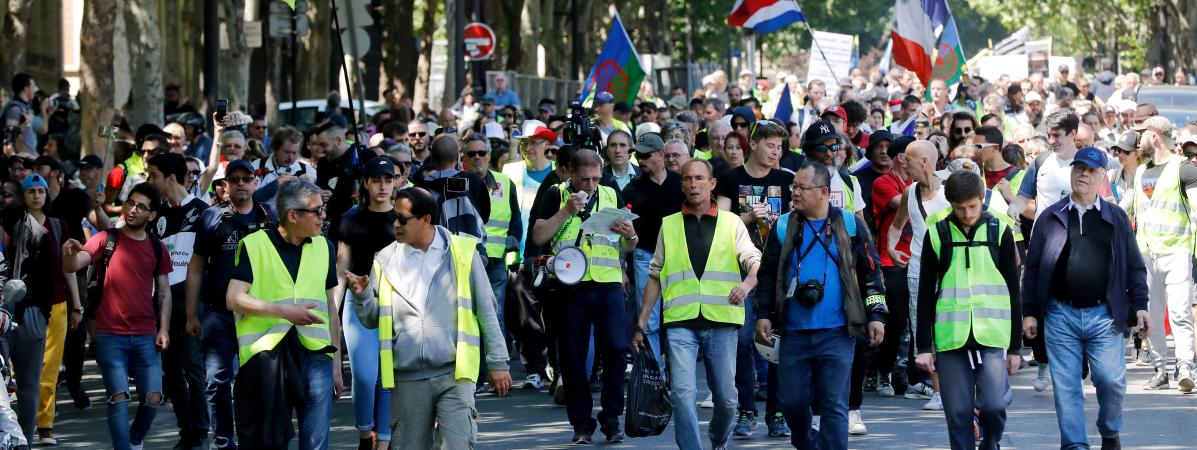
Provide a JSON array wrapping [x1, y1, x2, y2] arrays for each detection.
[[632, 159, 760, 449]]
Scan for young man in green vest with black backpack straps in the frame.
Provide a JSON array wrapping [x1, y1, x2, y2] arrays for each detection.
[[915, 171, 1022, 450]]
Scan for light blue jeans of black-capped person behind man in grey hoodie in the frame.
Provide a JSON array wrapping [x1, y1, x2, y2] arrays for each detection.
[[341, 292, 394, 442]]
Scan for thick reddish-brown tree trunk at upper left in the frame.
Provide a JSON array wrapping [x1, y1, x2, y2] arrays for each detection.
[[79, 0, 117, 174]]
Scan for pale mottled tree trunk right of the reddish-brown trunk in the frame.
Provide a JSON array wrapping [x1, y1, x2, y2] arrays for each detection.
[[123, 0, 163, 129]]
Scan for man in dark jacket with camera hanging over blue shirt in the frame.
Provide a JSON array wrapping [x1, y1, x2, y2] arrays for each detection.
[[755, 163, 887, 449]]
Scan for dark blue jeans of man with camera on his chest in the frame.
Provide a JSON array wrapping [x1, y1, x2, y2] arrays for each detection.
[[771, 327, 856, 450]]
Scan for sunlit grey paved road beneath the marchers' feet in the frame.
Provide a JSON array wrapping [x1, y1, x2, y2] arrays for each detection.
[[42, 349, 1197, 449]]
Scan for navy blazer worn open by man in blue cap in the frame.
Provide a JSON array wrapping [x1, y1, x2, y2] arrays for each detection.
[[1022, 197, 1148, 332]]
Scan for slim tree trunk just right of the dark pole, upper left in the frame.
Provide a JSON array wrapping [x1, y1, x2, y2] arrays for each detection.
[[218, 0, 249, 111]]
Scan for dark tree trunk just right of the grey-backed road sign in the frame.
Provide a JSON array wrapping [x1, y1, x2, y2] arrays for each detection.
[[378, 0, 417, 101]]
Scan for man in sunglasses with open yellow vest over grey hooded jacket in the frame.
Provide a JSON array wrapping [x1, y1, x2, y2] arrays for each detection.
[[346, 188, 511, 449]]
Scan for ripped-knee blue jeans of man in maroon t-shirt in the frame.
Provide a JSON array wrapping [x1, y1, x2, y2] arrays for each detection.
[[95, 333, 162, 450]]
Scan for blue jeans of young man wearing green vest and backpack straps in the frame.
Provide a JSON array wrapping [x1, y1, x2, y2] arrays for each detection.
[[935, 347, 1010, 450]]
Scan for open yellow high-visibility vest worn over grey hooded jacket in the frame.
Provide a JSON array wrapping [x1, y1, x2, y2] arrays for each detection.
[[373, 235, 482, 389]]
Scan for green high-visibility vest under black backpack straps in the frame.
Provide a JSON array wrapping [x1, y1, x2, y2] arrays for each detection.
[[926, 219, 1010, 352]]
